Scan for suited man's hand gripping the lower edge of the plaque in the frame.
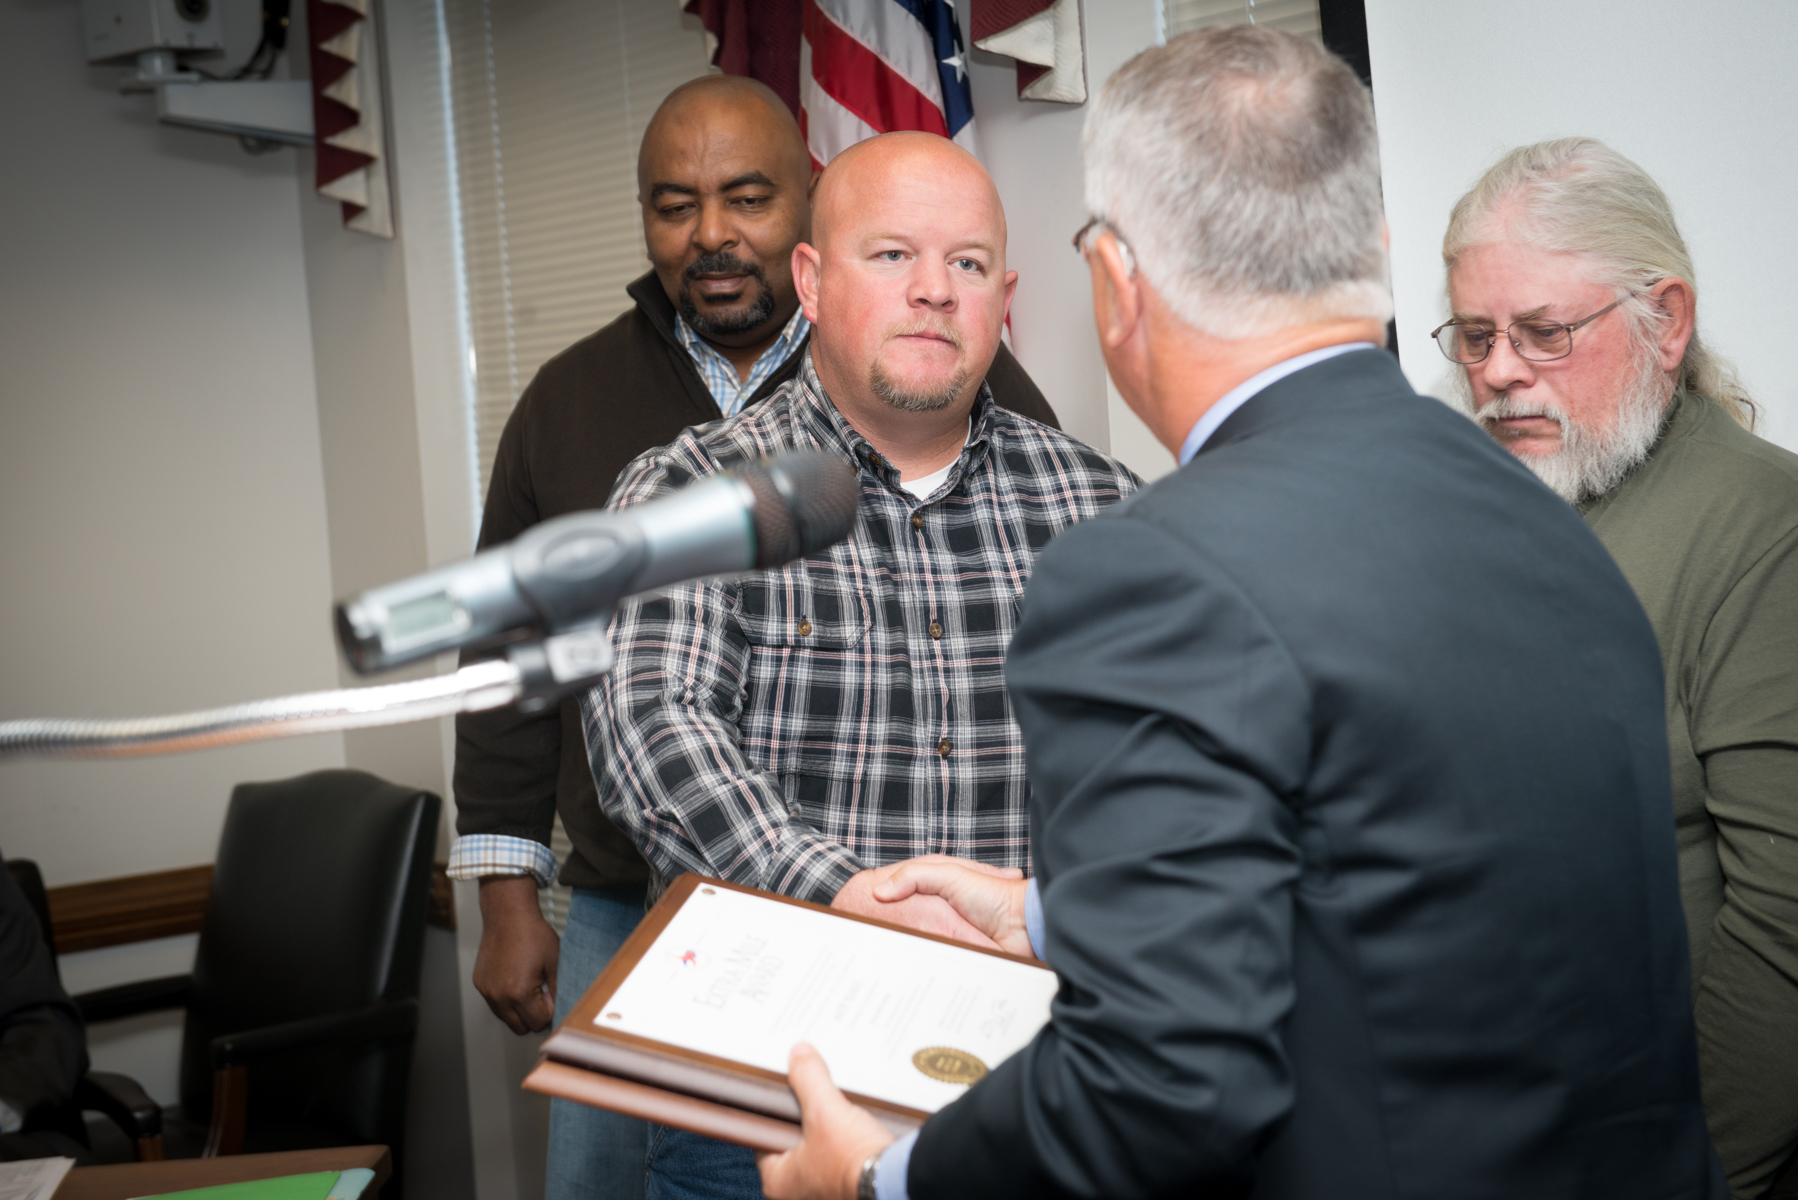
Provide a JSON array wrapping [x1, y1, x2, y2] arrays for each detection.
[[755, 1042, 894, 1200]]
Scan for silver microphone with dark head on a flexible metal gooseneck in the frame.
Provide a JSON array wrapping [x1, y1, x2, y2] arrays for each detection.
[[0, 450, 859, 759]]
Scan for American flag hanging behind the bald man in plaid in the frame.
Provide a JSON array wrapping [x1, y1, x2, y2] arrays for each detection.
[[798, 0, 980, 167]]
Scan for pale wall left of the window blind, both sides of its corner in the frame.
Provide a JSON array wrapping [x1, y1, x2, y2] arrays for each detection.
[[0, 0, 481, 1200]]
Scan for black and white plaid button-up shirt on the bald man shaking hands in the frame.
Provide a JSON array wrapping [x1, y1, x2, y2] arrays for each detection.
[[581, 354, 1138, 903]]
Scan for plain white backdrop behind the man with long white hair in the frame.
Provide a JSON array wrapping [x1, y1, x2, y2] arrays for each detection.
[[1366, 0, 1798, 448]]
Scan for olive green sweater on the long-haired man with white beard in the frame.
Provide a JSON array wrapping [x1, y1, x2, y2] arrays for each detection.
[[1582, 392, 1798, 1196]]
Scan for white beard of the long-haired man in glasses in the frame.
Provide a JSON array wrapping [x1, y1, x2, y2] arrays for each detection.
[[1455, 354, 1670, 504]]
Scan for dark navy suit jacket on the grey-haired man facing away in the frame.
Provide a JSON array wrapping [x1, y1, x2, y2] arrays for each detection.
[[908, 351, 1724, 1200]]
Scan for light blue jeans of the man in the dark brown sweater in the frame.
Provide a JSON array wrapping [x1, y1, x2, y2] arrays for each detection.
[[543, 889, 649, 1200]]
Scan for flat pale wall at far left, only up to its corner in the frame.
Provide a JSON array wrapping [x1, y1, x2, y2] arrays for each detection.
[[0, 0, 343, 1101]]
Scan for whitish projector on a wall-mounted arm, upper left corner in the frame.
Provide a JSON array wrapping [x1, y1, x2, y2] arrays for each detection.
[[81, 0, 313, 146]]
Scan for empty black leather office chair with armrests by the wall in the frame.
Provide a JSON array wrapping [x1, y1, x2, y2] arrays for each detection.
[[76, 770, 442, 1195]]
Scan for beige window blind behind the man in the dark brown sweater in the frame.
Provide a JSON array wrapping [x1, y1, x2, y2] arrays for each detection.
[[444, 0, 712, 497]]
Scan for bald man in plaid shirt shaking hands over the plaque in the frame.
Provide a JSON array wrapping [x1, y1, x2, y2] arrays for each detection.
[[583, 133, 1138, 978]]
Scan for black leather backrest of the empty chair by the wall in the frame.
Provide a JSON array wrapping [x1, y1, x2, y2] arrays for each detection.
[[182, 770, 442, 1144]]
